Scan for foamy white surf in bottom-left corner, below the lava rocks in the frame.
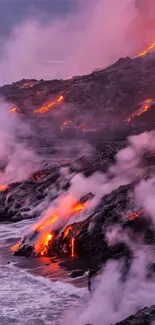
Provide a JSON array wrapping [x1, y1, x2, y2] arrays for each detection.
[[0, 264, 87, 325]]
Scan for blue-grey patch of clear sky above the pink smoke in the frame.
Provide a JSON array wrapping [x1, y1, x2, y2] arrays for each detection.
[[0, 0, 75, 37]]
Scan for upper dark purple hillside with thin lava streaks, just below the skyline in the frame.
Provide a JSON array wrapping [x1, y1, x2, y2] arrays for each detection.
[[0, 53, 155, 146]]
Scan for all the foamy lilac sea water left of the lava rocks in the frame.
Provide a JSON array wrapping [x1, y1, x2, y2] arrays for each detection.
[[0, 221, 88, 325]]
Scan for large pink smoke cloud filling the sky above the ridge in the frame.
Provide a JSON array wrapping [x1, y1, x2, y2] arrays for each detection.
[[0, 0, 136, 84]]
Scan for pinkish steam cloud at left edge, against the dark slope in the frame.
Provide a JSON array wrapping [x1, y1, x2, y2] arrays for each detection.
[[0, 99, 41, 184]]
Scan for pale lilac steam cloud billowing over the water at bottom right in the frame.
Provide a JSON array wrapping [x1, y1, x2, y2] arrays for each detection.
[[67, 245, 155, 325]]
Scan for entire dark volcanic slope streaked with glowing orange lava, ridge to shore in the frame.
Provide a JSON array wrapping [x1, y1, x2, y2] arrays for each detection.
[[0, 53, 155, 324]]
